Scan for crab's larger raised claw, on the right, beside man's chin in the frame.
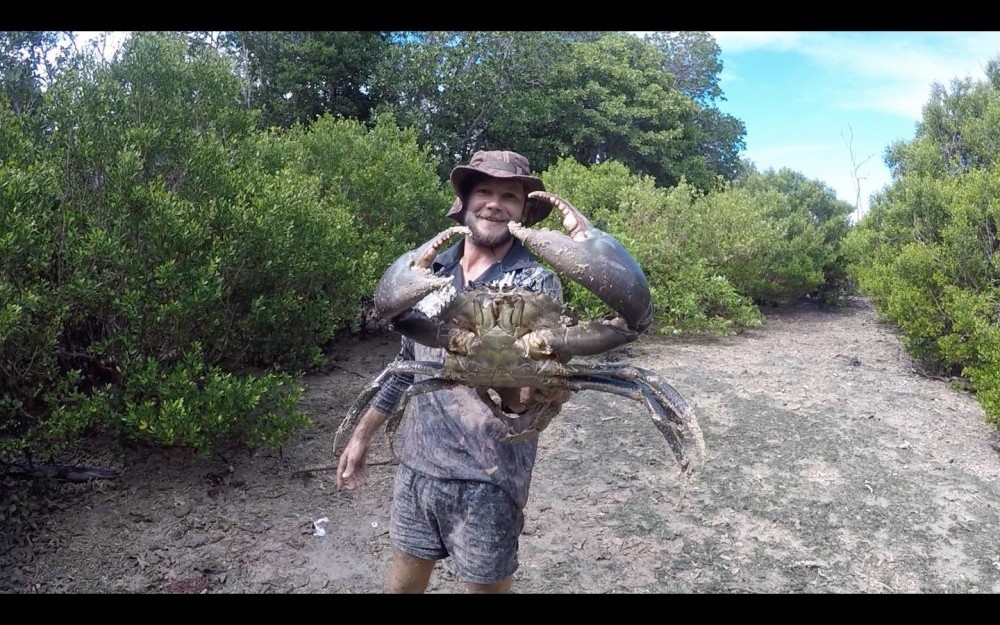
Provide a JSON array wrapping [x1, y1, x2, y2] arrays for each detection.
[[508, 191, 653, 332]]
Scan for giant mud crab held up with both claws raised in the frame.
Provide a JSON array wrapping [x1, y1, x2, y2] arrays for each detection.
[[334, 191, 705, 471]]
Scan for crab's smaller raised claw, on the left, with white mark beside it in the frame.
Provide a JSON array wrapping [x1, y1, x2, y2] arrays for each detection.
[[375, 226, 469, 319]]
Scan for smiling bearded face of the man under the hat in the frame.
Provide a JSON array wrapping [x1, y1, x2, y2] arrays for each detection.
[[464, 178, 527, 247]]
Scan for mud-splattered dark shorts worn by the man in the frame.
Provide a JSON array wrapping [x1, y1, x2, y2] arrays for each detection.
[[389, 465, 524, 584]]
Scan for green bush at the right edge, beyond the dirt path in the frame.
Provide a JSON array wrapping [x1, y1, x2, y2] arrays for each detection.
[[845, 60, 1000, 426]]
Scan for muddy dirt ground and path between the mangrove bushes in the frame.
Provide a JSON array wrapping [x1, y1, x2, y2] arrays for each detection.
[[0, 300, 1000, 594]]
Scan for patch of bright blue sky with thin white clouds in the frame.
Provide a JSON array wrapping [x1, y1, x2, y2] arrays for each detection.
[[711, 31, 1000, 218]]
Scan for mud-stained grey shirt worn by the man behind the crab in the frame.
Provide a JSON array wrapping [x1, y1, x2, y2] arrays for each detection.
[[375, 239, 562, 508]]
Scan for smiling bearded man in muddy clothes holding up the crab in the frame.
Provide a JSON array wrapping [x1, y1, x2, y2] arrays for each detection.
[[337, 151, 570, 593]]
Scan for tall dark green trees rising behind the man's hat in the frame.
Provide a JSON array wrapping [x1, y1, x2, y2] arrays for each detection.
[[308, 31, 745, 189]]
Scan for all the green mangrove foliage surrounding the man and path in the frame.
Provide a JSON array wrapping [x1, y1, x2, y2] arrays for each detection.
[[9, 31, 1000, 458]]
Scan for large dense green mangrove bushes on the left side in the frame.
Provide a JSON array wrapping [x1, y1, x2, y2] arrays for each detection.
[[0, 34, 448, 452]]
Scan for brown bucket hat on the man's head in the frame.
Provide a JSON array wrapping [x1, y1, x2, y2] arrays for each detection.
[[448, 150, 552, 226]]
